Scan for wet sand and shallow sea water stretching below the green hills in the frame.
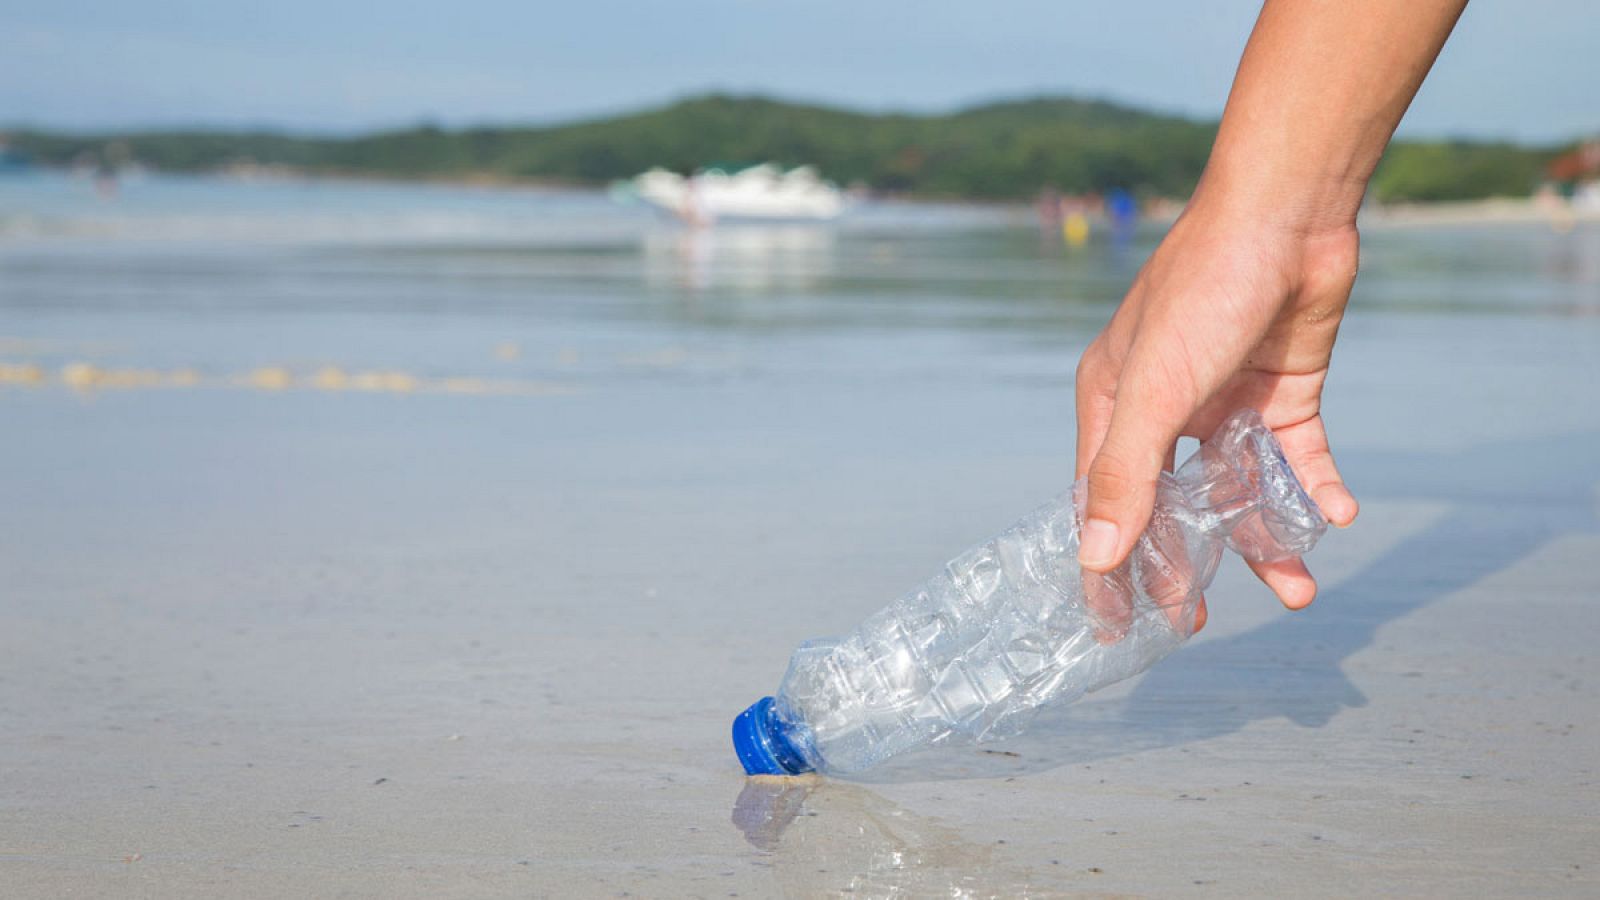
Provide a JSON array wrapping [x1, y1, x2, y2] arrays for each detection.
[[0, 176, 1600, 897]]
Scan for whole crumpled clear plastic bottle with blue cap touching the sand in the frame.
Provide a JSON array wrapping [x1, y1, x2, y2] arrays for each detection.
[[733, 410, 1328, 775]]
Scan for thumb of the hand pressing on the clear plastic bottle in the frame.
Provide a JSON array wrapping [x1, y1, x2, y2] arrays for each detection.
[[1078, 384, 1182, 572]]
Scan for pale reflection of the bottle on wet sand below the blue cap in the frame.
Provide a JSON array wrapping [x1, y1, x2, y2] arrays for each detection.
[[733, 775, 1027, 897]]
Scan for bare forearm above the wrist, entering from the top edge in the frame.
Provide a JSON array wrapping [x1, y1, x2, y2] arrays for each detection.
[[1197, 0, 1467, 231]]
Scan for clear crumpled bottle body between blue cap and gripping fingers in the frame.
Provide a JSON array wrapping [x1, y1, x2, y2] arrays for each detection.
[[778, 477, 1221, 772]]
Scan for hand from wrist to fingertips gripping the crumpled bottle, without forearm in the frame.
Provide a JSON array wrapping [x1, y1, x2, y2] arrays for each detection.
[[1077, 194, 1358, 614]]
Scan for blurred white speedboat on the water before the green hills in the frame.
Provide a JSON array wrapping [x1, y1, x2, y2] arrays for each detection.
[[627, 163, 845, 224]]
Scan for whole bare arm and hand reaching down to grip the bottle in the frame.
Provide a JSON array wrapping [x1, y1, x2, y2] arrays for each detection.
[[1078, 0, 1467, 614]]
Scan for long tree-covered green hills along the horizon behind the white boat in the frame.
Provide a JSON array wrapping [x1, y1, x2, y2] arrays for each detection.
[[11, 94, 1550, 200]]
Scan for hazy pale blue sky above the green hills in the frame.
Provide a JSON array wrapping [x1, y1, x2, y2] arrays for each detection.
[[0, 0, 1600, 139]]
